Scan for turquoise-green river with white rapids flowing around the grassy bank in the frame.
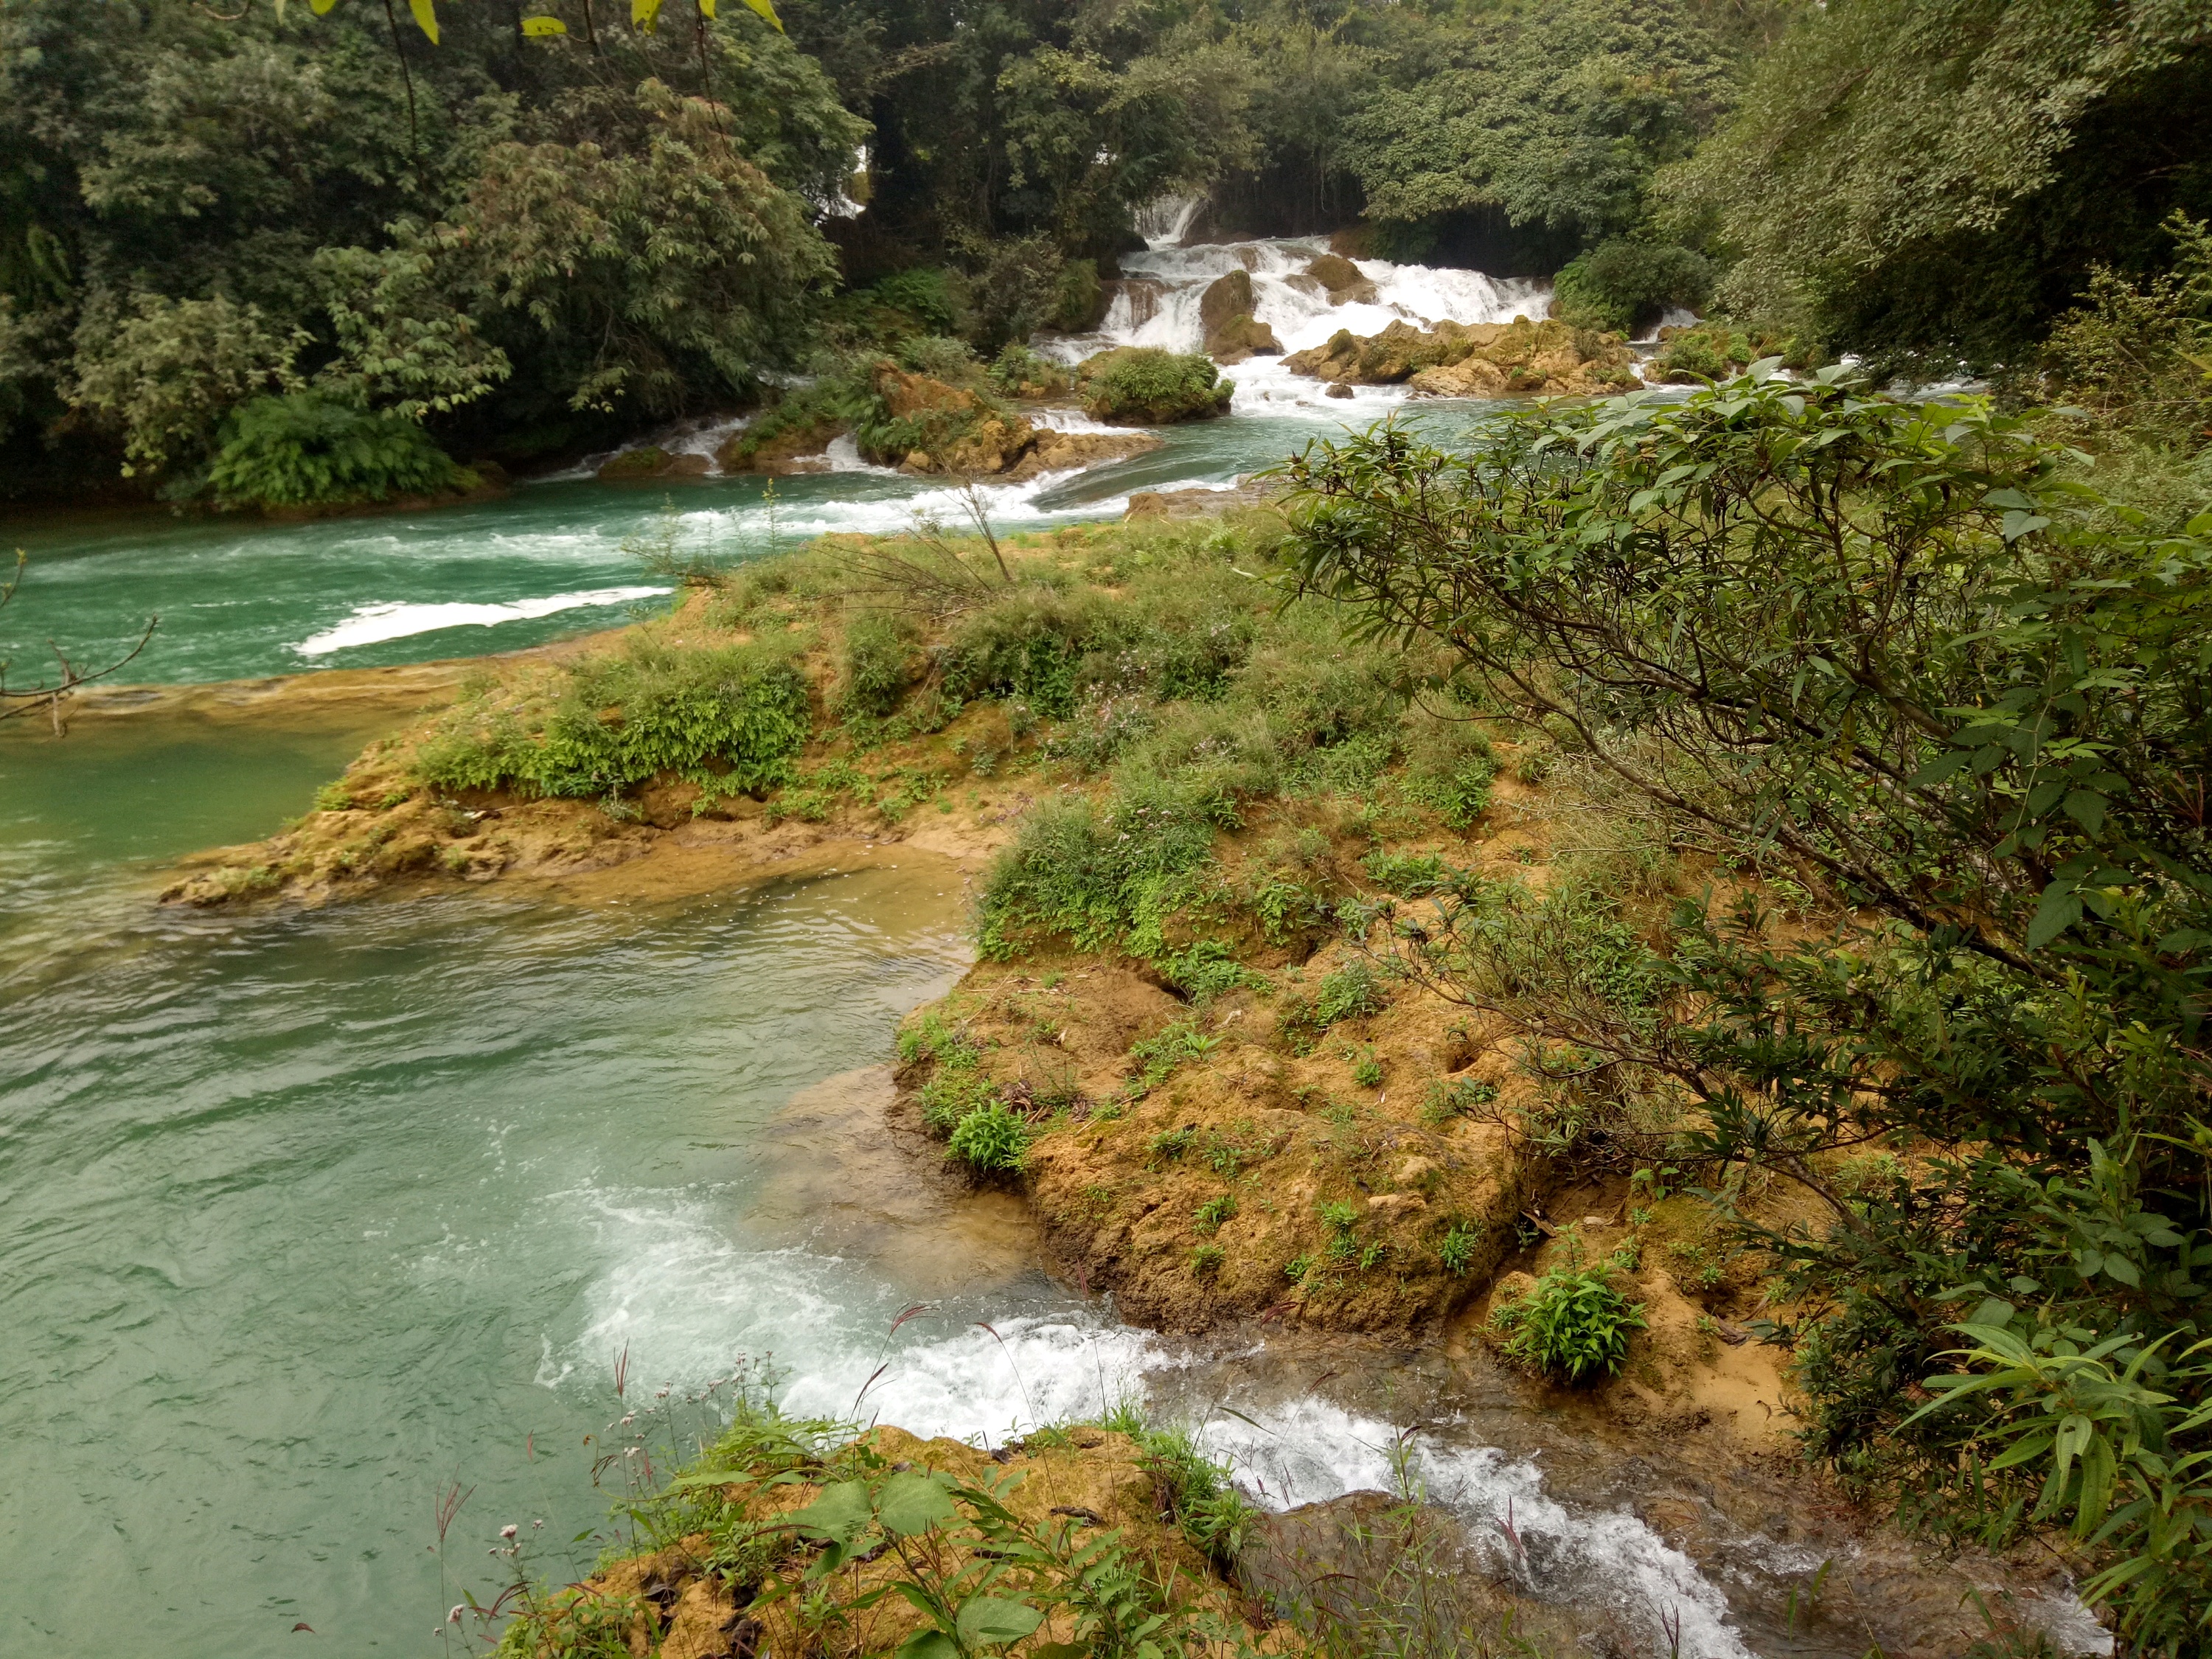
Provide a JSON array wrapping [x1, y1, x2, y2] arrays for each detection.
[[0, 243, 2095, 1659]]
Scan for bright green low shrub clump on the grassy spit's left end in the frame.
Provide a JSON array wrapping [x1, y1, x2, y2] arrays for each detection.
[[416, 639, 812, 805]]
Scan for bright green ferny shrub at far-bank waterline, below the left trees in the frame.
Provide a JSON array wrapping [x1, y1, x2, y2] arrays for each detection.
[[208, 392, 476, 507]]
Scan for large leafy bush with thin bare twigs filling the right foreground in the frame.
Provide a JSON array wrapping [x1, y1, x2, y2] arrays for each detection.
[[1292, 363, 2212, 1652]]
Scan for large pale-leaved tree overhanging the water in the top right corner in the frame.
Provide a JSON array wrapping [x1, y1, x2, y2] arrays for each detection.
[[1666, 0, 2212, 363]]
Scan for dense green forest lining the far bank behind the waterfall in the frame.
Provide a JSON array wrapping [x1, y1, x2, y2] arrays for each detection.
[[0, 0, 2212, 502]]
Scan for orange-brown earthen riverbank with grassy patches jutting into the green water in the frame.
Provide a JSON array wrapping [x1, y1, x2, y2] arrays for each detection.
[[138, 509, 2106, 1655]]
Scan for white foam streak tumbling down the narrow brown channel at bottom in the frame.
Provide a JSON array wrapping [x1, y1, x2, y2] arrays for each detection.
[[1201, 1398, 1778, 1659]]
